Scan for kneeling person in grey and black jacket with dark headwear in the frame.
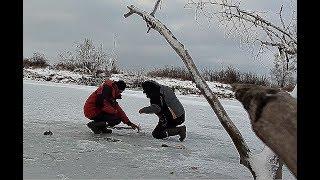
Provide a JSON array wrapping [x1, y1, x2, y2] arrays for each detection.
[[139, 80, 186, 141]]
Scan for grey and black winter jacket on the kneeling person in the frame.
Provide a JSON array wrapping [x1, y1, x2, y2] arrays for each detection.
[[141, 80, 185, 119]]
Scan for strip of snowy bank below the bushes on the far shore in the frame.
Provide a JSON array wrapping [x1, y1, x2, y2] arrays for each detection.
[[23, 68, 234, 98]]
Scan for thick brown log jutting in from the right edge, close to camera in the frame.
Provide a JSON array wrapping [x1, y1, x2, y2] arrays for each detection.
[[233, 84, 297, 177]]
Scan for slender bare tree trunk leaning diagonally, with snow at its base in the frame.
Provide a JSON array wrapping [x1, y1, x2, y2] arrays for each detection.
[[124, 0, 288, 179]]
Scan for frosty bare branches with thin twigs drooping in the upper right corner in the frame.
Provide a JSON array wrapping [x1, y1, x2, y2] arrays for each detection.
[[185, 0, 298, 90]]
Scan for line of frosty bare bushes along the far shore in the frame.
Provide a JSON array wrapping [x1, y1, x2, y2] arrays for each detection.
[[23, 39, 296, 90]]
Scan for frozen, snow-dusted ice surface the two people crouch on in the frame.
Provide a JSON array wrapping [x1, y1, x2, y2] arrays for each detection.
[[23, 80, 295, 179]]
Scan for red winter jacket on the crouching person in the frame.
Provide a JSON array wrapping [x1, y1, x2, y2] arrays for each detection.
[[83, 80, 131, 125]]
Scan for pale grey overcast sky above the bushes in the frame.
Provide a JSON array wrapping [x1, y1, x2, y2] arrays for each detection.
[[23, 0, 291, 74]]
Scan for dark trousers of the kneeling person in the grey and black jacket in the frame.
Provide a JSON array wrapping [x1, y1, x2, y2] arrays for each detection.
[[152, 114, 185, 139]]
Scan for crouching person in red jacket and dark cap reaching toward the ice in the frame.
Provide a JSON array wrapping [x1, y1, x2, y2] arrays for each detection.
[[83, 80, 140, 134]]
